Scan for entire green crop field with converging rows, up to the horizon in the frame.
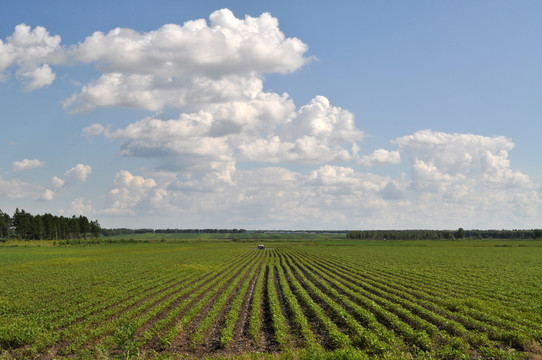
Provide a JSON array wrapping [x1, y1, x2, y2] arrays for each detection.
[[0, 240, 542, 359]]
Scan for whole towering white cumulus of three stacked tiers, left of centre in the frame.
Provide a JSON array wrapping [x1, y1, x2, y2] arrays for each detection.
[[68, 9, 363, 172]]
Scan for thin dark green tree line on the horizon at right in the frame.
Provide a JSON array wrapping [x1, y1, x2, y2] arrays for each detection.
[[346, 228, 542, 240]]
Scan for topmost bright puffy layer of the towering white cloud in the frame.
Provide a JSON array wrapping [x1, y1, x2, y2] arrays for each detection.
[[72, 9, 307, 78]]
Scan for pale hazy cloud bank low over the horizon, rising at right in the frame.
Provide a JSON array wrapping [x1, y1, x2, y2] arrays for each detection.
[[95, 130, 541, 229]]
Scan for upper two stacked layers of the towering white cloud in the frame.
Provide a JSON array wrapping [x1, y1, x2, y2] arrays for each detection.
[[64, 9, 309, 112]]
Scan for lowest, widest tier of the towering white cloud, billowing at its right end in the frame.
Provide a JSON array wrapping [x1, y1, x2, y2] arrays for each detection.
[[102, 93, 363, 177]]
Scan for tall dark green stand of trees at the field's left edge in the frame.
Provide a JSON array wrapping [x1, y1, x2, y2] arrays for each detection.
[[0, 208, 101, 240]]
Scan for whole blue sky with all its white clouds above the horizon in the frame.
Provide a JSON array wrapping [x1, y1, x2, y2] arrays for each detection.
[[0, 0, 542, 230]]
